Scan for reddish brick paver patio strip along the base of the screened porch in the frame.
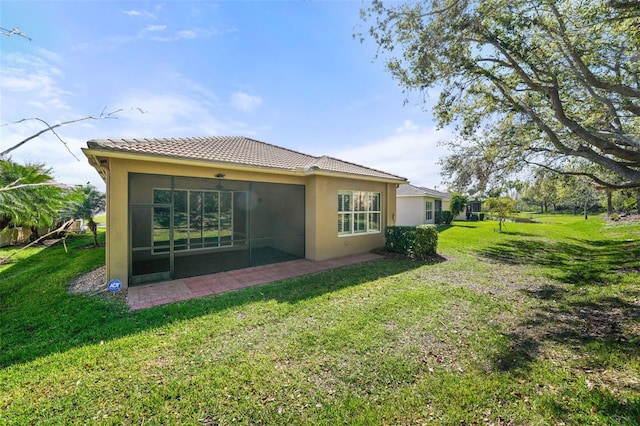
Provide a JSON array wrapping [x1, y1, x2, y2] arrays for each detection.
[[127, 253, 382, 311]]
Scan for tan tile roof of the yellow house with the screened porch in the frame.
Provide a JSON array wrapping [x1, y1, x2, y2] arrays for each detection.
[[87, 136, 407, 181]]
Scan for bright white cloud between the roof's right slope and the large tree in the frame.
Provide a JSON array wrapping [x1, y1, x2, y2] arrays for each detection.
[[329, 120, 453, 189]]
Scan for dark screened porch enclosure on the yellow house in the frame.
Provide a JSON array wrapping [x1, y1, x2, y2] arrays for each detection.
[[129, 173, 305, 285]]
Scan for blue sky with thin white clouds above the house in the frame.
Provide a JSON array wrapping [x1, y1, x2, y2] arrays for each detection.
[[0, 0, 453, 190]]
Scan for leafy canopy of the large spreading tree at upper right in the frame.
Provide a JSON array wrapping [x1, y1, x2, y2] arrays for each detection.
[[361, 0, 640, 188]]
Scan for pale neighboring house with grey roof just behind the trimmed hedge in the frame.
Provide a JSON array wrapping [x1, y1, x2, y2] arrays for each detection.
[[396, 184, 451, 226]]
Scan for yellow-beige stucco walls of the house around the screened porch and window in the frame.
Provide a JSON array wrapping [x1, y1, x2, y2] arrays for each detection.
[[87, 154, 396, 286]]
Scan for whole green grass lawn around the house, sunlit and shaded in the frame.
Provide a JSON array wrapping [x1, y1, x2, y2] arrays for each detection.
[[0, 216, 640, 425]]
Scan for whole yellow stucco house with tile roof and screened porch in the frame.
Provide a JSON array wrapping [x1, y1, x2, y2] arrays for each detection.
[[83, 136, 406, 287]]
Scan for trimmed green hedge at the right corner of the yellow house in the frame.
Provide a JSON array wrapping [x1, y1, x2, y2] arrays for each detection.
[[384, 225, 438, 257]]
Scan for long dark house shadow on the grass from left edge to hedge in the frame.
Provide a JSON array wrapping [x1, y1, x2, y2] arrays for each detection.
[[0, 243, 425, 369]]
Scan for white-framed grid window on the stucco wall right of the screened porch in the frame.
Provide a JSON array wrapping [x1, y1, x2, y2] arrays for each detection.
[[338, 191, 382, 235]]
